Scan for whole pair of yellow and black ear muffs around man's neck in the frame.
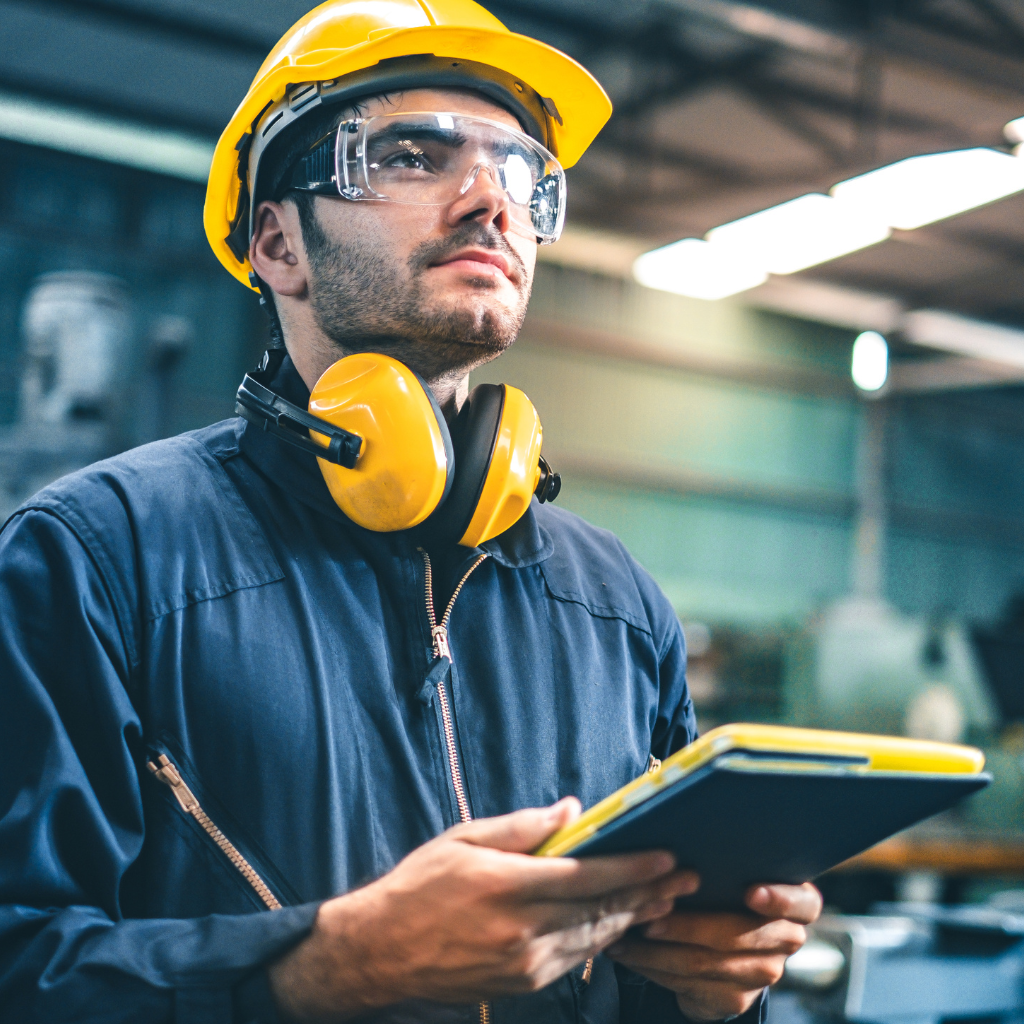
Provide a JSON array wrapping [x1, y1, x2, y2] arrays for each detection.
[[236, 351, 561, 547]]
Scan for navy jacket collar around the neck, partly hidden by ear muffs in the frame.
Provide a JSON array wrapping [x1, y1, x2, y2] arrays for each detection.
[[239, 356, 554, 568]]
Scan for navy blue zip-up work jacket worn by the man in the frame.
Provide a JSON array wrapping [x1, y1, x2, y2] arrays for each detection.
[[0, 362, 753, 1024]]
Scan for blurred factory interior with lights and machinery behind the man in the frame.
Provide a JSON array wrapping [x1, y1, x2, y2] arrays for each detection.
[[6, 0, 1024, 1021]]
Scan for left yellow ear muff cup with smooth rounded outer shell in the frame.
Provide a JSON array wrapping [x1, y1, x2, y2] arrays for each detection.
[[309, 352, 453, 534]]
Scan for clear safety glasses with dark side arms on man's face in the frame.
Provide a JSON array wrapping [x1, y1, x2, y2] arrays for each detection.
[[286, 113, 565, 245]]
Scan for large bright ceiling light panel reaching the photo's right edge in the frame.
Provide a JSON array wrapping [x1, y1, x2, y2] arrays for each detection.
[[831, 148, 1024, 230]]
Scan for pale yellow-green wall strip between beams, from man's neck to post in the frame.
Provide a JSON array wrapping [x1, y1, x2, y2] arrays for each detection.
[[474, 342, 860, 496]]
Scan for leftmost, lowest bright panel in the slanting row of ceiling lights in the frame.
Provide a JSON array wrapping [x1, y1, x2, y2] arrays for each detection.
[[633, 239, 768, 299]]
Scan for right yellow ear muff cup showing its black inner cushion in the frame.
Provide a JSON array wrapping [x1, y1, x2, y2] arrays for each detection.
[[438, 384, 543, 548]]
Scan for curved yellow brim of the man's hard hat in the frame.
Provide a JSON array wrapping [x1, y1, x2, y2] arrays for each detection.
[[203, 26, 611, 287]]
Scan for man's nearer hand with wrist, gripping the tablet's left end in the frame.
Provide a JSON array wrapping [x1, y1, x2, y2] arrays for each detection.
[[269, 798, 697, 1021]]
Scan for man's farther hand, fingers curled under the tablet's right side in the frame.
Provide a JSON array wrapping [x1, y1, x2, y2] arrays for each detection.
[[608, 884, 821, 1021]]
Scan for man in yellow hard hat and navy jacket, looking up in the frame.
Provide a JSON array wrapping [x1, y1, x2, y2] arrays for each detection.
[[0, 0, 820, 1024]]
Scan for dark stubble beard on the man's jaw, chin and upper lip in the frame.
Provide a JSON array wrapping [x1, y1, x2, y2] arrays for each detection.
[[307, 222, 529, 381]]
